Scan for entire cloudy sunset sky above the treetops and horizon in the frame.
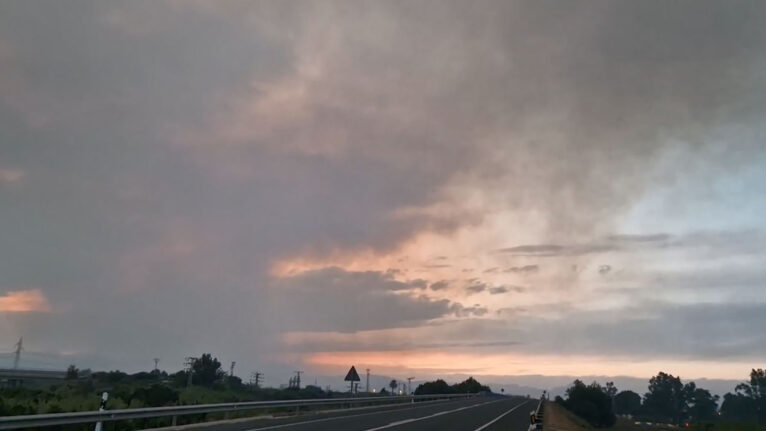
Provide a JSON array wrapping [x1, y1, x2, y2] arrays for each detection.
[[0, 0, 766, 389]]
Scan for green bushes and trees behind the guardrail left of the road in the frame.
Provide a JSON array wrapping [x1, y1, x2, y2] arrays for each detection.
[[0, 354, 380, 431]]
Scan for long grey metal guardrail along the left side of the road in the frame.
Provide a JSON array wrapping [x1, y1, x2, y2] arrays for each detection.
[[0, 394, 476, 430]]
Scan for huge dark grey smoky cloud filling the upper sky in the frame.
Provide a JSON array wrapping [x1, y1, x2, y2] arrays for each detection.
[[0, 1, 766, 374]]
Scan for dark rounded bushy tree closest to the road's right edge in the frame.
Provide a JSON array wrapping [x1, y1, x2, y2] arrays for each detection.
[[563, 380, 617, 428]]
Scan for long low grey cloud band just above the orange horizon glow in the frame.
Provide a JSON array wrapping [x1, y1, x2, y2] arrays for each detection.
[[292, 302, 766, 364]]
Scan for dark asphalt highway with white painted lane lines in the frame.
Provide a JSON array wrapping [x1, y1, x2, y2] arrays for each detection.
[[178, 397, 538, 431]]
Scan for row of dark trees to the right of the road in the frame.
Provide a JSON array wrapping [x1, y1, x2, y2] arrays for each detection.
[[556, 368, 766, 427]]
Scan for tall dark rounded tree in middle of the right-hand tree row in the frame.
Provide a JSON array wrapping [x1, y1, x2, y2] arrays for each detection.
[[643, 372, 686, 424]]
